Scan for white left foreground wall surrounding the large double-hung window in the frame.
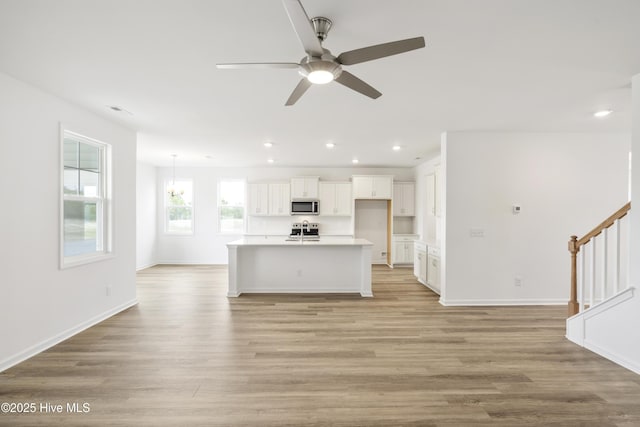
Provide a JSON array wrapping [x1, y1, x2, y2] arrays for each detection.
[[0, 73, 136, 371]]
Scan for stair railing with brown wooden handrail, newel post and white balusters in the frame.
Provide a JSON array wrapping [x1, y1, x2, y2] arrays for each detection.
[[568, 202, 631, 317]]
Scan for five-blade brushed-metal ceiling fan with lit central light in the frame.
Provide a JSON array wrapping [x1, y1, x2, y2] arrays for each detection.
[[216, 0, 425, 105]]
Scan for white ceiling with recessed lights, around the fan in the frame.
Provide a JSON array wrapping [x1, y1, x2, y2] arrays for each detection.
[[0, 0, 640, 167]]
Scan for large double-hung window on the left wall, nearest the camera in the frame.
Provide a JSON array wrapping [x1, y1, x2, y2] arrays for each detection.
[[60, 129, 110, 267]]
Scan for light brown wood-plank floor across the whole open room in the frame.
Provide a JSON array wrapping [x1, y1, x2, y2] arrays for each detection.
[[0, 266, 640, 427]]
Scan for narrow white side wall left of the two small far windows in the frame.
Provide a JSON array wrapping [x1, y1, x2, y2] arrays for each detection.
[[136, 162, 158, 270]]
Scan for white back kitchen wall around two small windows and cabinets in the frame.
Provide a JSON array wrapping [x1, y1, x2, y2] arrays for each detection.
[[156, 166, 413, 264]]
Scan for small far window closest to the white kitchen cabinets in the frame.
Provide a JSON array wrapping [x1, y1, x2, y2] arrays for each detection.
[[218, 179, 245, 234]]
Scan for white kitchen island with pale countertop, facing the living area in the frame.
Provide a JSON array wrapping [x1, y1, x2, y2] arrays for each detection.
[[227, 236, 373, 297]]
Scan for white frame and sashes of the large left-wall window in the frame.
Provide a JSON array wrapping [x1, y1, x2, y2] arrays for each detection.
[[59, 123, 113, 269]]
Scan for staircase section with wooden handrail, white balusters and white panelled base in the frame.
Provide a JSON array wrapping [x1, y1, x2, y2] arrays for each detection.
[[566, 203, 640, 374]]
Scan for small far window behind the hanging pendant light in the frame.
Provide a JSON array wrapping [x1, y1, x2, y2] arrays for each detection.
[[164, 179, 193, 234]]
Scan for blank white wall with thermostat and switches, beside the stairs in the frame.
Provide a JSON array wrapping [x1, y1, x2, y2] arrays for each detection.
[[441, 133, 631, 305]]
